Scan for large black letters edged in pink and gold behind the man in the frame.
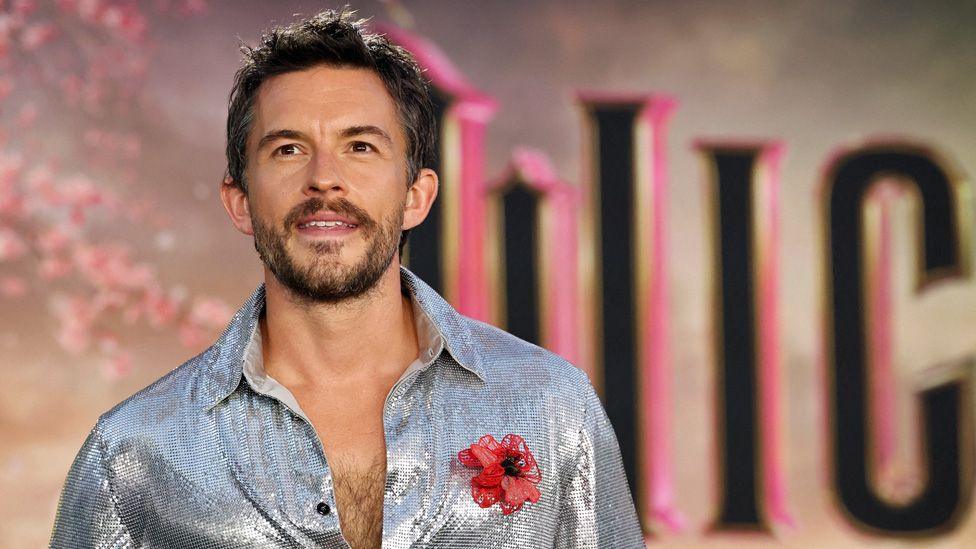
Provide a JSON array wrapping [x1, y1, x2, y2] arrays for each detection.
[[388, 27, 974, 537]]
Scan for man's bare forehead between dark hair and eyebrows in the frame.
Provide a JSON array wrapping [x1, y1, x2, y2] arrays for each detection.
[[255, 65, 402, 141]]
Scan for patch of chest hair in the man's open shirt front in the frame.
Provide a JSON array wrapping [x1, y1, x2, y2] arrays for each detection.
[[332, 459, 386, 549]]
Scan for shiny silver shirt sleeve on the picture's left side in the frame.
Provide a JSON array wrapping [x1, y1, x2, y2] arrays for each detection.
[[50, 425, 135, 549]]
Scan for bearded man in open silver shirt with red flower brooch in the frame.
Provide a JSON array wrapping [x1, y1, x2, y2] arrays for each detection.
[[51, 11, 643, 549]]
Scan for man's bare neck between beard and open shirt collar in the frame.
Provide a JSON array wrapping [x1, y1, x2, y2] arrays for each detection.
[[260, 258, 418, 386]]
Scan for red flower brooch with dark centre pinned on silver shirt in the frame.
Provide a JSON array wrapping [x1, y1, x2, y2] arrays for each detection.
[[458, 434, 542, 515]]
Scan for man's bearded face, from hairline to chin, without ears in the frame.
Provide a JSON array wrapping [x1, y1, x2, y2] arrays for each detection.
[[246, 66, 407, 302]]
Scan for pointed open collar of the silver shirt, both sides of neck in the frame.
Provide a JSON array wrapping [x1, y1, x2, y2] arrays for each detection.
[[199, 266, 485, 409]]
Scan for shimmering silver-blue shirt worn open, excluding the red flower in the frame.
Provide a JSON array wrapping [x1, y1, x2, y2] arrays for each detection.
[[51, 269, 644, 549]]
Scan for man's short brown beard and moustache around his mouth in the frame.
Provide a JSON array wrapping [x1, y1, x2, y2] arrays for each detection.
[[251, 198, 403, 303]]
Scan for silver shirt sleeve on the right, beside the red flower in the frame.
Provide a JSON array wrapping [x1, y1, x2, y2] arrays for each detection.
[[556, 382, 645, 549]]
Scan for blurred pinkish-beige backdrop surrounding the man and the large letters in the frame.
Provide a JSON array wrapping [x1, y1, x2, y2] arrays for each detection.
[[0, 0, 976, 547]]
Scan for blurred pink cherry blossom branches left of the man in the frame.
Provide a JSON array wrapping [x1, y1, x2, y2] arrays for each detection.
[[0, 0, 231, 377]]
